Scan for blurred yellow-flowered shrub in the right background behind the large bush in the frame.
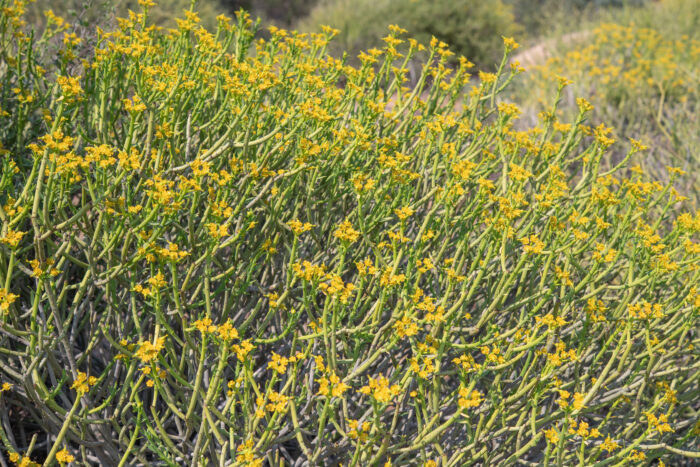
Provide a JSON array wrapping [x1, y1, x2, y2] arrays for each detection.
[[521, 9, 700, 198]]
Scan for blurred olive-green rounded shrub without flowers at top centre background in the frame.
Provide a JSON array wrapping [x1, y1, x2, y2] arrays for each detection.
[[300, 0, 518, 68]]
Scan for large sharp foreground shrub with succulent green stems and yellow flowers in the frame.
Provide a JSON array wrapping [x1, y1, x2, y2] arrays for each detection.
[[0, 0, 700, 466]]
